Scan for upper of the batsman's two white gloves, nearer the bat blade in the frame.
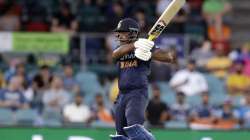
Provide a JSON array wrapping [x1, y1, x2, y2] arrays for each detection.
[[134, 38, 155, 52]]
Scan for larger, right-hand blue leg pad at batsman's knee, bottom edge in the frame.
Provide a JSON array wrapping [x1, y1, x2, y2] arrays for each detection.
[[123, 124, 155, 140]]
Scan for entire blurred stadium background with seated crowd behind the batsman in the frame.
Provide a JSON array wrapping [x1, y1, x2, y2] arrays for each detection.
[[0, 0, 250, 140]]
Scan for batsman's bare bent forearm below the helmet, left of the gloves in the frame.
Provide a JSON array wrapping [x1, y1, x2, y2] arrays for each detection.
[[112, 44, 135, 59]]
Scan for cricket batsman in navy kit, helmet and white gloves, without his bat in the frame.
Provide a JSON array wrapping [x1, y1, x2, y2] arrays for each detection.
[[110, 18, 176, 140]]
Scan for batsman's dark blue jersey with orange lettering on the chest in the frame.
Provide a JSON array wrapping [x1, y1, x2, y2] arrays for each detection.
[[117, 52, 150, 93]]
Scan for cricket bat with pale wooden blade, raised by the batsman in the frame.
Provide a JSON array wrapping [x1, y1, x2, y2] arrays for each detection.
[[148, 0, 186, 41]]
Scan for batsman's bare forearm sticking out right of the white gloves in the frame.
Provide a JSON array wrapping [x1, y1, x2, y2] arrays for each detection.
[[152, 49, 176, 63]]
